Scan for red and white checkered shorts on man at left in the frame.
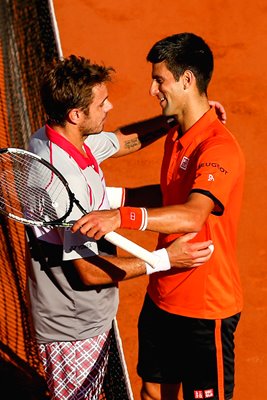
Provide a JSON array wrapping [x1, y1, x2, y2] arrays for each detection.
[[38, 332, 110, 400]]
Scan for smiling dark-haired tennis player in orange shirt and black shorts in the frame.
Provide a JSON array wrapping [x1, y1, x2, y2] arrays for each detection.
[[73, 33, 245, 400]]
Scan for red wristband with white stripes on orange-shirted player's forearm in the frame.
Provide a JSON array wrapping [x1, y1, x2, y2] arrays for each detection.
[[119, 207, 147, 230]]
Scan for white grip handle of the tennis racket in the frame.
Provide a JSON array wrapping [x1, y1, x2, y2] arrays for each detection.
[[104, 232, 159, 268]]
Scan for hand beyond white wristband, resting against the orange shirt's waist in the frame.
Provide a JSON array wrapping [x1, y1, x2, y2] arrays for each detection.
[[166, 233, 213, 268]]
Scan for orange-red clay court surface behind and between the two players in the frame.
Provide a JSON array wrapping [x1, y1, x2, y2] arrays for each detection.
[[54, 0, 267, 400]]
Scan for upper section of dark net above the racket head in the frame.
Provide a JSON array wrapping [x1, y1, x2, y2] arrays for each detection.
[[0, 0, 57, 147]]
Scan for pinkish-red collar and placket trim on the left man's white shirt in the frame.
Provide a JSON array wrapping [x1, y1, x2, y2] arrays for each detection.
[[45, 124, 99, 173]]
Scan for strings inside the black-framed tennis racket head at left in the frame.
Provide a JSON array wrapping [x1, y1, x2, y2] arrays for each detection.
[[0, 153, 70, 223]]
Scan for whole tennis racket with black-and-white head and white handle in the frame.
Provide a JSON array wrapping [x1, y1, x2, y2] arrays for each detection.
[[0, 148, 158, 267]]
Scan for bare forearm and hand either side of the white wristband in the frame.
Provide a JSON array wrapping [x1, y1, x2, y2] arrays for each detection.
[[73, 233, 212, 286]]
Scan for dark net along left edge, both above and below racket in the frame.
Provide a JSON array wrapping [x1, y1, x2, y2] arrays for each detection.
[[0, 0, 58, 399]]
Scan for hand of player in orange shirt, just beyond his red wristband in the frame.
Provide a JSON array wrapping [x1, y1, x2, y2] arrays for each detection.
[[71, 210, 121, 240]]
